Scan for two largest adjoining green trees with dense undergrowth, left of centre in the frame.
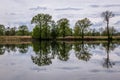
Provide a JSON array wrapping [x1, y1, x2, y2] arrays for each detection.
[[31, 14, 72, 39]]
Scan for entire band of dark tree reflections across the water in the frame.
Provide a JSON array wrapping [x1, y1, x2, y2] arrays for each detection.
[[0, 41, 119, 68]]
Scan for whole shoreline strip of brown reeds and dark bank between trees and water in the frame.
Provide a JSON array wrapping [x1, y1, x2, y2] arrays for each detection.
[[0, 36, 120, 43]]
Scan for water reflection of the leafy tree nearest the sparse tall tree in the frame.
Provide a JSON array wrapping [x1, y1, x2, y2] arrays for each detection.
[[74, 41, 92, 61]]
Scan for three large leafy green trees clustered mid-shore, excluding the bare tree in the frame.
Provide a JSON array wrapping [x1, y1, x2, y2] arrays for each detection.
[[31, 14, 92, 39]]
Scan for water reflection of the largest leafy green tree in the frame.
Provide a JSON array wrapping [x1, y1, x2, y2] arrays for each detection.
[[31, 42, 52, 66]]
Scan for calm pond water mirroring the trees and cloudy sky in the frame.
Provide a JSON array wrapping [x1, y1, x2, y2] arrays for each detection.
[[0, 41, 120, 80]]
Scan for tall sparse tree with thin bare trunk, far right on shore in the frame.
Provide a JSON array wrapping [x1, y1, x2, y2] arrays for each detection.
[[101, 11, 114, 39]]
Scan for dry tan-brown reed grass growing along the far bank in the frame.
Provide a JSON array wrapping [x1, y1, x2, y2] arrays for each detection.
[[0, 36, 120, 43]]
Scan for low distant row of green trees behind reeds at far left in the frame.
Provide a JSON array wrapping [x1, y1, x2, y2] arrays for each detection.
[[0, 24, 30, 36]]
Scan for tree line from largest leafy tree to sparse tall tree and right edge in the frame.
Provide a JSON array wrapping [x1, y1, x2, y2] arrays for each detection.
[[31, 11, 120, 39]]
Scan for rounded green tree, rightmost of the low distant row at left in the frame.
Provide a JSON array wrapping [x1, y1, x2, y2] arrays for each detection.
[[17, 25, 29, 36]]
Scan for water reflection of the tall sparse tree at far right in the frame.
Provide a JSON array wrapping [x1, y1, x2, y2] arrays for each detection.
[[103, 40, 116, 68]]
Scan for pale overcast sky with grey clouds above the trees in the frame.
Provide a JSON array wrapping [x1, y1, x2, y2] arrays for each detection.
[[0, 0, 120, 30]]
